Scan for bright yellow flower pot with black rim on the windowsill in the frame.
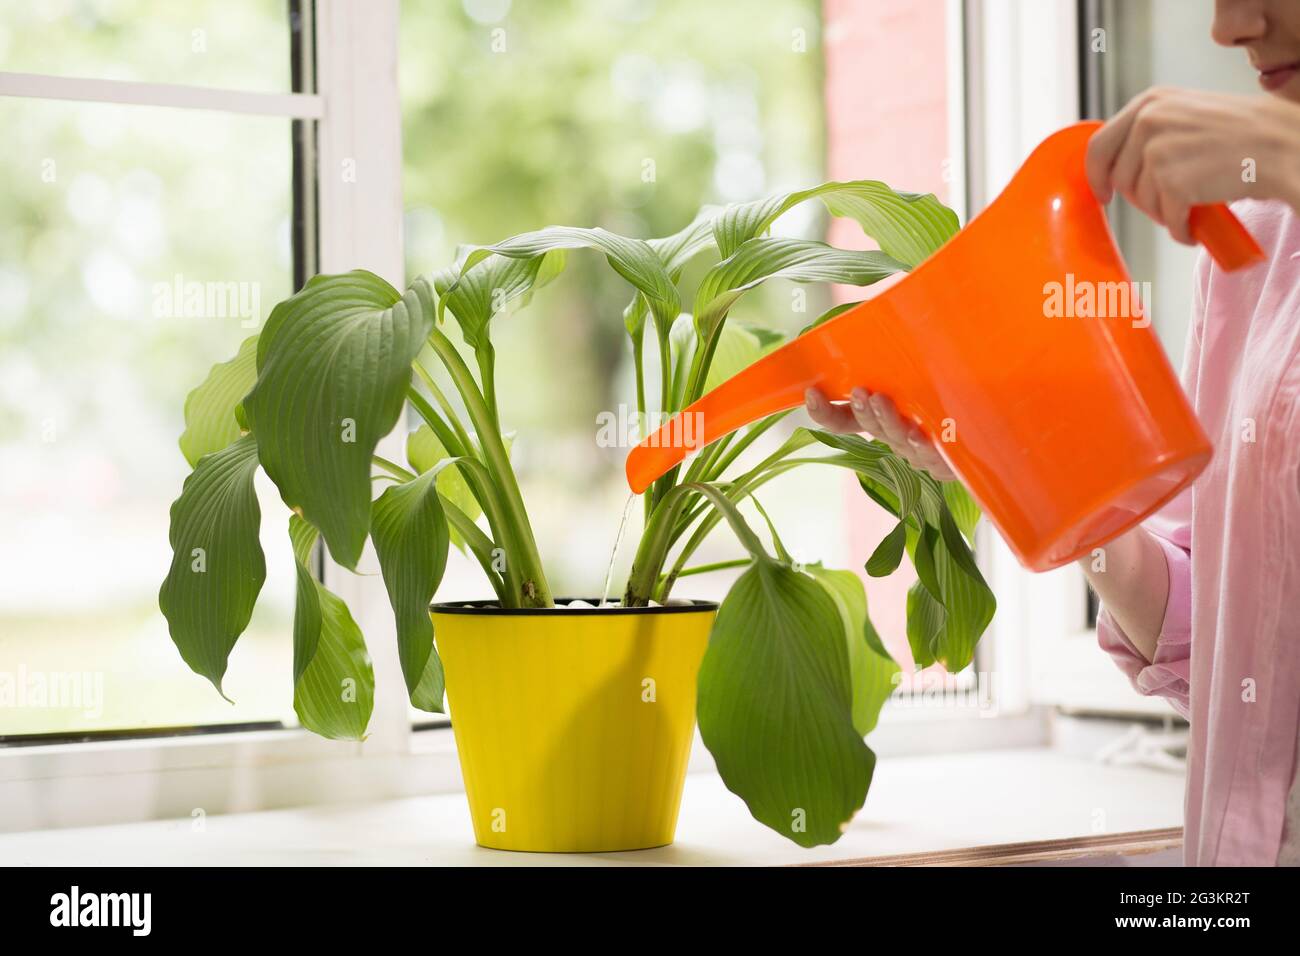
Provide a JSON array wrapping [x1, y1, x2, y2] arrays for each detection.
[[430, 601, 718, 853]]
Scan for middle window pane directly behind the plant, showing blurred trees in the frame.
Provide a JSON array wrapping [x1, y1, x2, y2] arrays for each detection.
[[399, 0, 821, 650]]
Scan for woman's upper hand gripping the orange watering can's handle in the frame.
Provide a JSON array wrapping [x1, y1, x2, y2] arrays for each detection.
[[1087, 87, 1300, 245]]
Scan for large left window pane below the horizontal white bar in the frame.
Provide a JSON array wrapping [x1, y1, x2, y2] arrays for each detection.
[[0, 99, 294, 735]]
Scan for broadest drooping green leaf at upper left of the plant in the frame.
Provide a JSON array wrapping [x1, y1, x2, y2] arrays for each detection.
[[244, 271, 433, 568]]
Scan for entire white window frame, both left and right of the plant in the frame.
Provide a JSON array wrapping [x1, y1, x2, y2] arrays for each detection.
[[0, 0, 1164, 831]]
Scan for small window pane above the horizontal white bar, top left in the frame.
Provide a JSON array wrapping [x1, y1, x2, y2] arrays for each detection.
[[0, 0, 290, 92]]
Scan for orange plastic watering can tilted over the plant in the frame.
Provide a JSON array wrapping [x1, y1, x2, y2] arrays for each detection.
[[627, 122, 1264, 571]]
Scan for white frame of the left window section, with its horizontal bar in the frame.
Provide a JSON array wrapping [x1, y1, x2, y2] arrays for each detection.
[[0, 0, 473, 831]]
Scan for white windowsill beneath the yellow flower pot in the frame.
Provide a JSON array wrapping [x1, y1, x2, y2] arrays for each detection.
[[0, 748, 1183, 866]]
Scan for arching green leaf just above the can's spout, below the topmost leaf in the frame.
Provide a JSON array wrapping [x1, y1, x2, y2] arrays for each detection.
[[694, 239, 907, 338]]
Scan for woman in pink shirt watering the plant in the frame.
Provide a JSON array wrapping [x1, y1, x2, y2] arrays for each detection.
[[807, 0, 1300, 865]]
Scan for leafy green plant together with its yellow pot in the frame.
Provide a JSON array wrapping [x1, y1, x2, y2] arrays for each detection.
[[160, 181, 995, 851]]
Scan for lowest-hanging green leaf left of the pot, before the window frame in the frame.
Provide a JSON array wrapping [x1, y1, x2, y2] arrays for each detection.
[[289, 515, 374, 740]]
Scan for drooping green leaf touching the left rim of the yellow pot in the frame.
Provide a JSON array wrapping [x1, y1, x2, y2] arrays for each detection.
[[371, 467, 450, 713]]
